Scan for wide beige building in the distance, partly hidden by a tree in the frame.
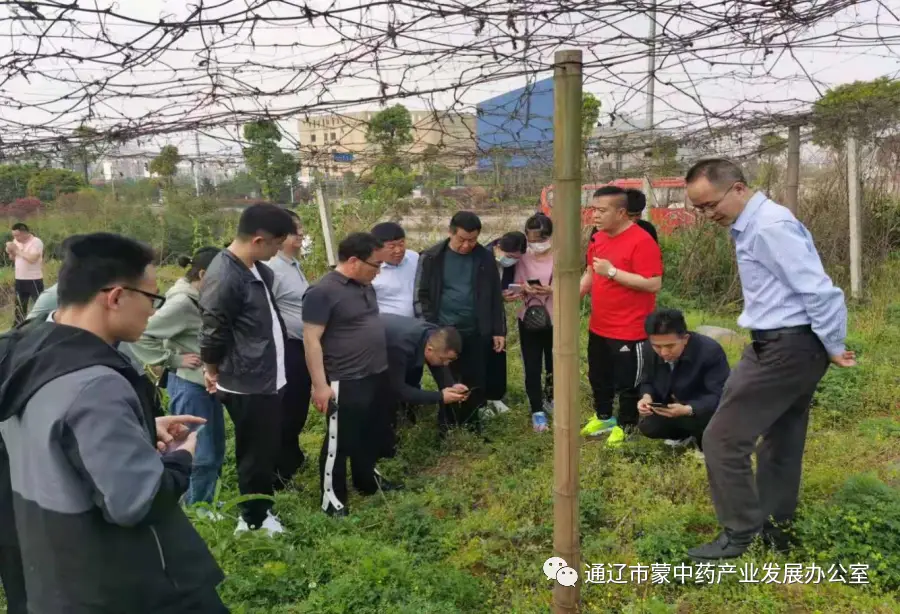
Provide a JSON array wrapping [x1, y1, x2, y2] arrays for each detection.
[[298, 111, 475, 182]]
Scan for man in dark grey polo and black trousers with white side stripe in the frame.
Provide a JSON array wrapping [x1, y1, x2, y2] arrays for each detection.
[[303, 232, 405, 516]]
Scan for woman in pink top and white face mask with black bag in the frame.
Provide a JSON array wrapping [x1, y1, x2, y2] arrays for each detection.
[[515, 213, 553, 433]]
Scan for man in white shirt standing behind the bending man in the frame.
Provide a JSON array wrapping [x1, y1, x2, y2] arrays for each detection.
[[372, 222, 423, 423]]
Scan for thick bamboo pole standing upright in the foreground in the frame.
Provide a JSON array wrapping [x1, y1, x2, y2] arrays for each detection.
[[553, 51, 583, 614]]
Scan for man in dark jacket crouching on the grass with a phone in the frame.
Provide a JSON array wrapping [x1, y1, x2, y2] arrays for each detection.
[[638, 309, 730, 451]]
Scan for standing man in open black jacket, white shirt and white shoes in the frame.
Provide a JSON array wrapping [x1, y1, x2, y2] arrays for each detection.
[[200, 204, 294, 535]]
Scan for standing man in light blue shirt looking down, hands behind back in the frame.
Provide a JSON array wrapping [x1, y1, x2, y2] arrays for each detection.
[[686, 159, 856, 561]]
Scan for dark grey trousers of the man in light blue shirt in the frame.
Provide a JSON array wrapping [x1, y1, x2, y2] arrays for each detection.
[[703, 332, 829, 538]]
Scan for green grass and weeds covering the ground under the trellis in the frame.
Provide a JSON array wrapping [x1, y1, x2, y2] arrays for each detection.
[[1, 265, 900, 614]]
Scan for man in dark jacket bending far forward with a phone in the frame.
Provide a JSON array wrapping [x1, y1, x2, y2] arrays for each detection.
[[380, 313, 466, 456]]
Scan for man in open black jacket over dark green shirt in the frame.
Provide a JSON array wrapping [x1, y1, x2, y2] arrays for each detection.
[[415, 211, 506, 433]]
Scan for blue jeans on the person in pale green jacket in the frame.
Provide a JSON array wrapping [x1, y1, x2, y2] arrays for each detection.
[[166, 372, 225, 505]]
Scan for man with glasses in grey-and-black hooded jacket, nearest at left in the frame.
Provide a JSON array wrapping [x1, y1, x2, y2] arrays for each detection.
[[0, 233, 228, 614]]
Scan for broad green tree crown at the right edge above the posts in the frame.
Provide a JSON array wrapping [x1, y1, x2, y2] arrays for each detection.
[[812, 77, 900, 150]]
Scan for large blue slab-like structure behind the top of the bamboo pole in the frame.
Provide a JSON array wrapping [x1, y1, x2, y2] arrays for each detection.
[[476, 77, 553, 170]]
